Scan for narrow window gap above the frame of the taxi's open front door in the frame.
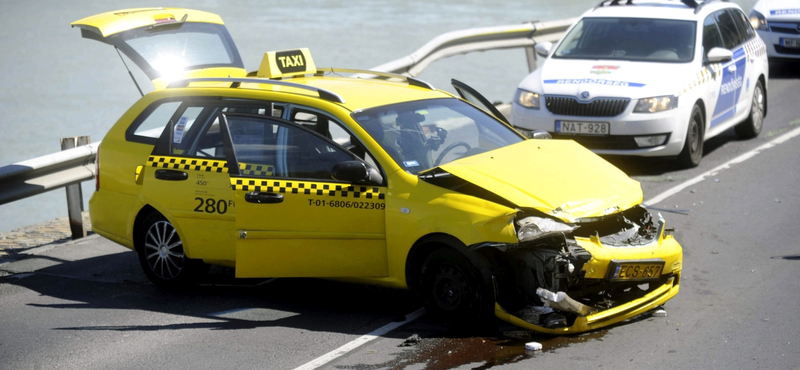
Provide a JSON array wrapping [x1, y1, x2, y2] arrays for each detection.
[[290, 108, 379, 168]]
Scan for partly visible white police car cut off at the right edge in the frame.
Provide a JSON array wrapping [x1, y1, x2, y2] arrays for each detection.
[[750, 0, 800, 61]]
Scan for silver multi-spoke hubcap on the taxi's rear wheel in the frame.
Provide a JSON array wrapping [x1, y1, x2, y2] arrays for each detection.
[[144, 221, 184, 280]]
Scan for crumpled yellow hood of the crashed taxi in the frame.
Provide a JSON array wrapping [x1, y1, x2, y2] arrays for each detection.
[[440, 140, 642, 222]]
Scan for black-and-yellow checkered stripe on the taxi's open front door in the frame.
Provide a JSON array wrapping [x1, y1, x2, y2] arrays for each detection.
[[231, 179, 386, 199]]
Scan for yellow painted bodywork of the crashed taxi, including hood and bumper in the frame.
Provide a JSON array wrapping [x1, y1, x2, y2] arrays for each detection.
[[86, 32, 682, 334]]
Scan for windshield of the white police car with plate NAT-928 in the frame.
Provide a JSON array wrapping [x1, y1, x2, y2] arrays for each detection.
[[553, 18, 697, 63]]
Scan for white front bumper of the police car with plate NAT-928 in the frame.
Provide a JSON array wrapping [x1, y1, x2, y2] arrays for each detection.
[[511, 104, 686, 157]]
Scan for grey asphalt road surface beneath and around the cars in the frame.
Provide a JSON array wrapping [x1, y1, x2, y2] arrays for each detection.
[[0, 48, 800, 369]]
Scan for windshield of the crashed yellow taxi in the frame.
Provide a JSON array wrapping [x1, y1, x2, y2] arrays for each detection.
[[353, 99, 524, 173]]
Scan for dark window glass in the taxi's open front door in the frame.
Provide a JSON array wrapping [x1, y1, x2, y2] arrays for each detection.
[[227, 115, 353, 181]]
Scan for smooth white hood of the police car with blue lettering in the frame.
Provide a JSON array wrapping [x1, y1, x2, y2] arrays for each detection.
[[541, 59, 690, 100]]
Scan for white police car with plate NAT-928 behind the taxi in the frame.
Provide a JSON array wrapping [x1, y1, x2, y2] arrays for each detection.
[[512, 0, 769, 167]]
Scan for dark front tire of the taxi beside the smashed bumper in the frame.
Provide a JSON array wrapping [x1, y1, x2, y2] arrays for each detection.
[[422, 248, 494, 325]]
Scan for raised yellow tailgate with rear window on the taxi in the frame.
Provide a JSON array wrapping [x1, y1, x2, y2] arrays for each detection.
[[72, 8, 247, 89]]
